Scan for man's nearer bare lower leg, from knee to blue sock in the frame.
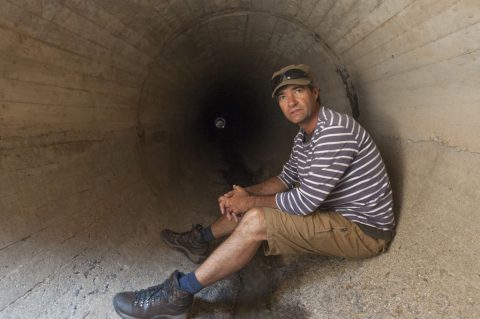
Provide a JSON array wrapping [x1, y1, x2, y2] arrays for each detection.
[[195, 208, 267, 286]]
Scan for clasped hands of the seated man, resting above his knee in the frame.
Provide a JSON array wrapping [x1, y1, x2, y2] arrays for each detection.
[[218, 185, 253, 222]]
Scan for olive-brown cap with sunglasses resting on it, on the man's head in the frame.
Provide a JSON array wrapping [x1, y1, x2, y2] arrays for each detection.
[[271, 64, 313, 98]]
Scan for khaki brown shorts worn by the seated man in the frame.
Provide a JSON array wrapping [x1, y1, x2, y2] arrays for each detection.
[[263, 208, 387, 258]]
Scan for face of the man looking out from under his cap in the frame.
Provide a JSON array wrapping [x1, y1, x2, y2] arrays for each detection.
[[277, 85, 319, 127]]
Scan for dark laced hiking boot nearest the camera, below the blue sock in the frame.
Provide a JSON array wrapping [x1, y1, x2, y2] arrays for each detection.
[[113, 270, 193, 319]]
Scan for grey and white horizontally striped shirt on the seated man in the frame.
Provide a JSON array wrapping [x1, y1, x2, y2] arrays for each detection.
[[275, 106, 395, 230]]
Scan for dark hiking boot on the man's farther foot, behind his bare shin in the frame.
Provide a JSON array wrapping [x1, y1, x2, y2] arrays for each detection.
[[161, 224, 208, 264]]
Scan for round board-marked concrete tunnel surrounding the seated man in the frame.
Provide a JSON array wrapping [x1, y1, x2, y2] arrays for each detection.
[[0, 0, 480, 318]]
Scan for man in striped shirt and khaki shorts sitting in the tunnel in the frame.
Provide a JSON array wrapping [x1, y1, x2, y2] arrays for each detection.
[[114, 64, 395, 318]]
